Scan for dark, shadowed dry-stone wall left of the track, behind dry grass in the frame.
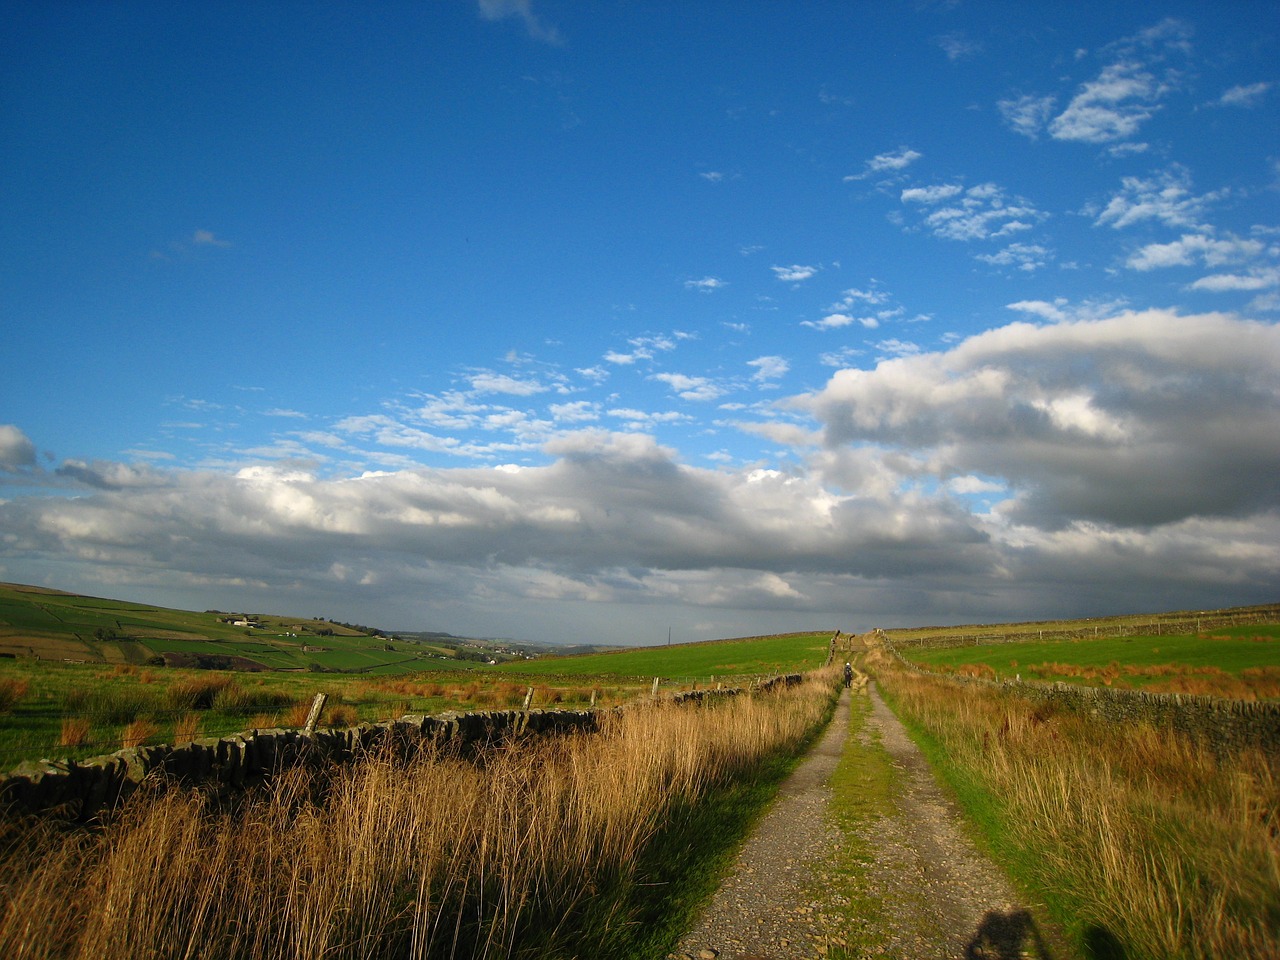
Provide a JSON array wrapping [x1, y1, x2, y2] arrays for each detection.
[[0, 673, 801, 820]]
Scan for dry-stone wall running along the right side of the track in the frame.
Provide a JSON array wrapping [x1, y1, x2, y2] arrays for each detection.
[[881, 635, 1280, 756]]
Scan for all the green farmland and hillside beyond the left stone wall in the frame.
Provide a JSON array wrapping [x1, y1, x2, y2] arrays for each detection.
[[0, 584, 829, 769]]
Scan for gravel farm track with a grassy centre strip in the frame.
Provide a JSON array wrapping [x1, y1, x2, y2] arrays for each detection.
[[671, 685, 1064, 960]]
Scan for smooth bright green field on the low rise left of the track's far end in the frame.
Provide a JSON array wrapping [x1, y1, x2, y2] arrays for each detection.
[[492, 631, 835, 681]]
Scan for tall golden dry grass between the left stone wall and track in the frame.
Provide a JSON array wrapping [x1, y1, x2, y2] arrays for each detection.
[[0, 676, 835, 960]]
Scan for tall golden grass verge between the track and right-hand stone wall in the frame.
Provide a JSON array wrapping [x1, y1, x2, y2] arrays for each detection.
[[879, 669, 1280, 959]]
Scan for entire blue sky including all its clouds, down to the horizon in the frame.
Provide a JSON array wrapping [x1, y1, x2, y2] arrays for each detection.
[[0, 0, 1280, 643]]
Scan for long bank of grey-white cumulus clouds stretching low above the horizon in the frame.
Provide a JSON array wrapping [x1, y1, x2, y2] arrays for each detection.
[[0, 312, 1280, 639]]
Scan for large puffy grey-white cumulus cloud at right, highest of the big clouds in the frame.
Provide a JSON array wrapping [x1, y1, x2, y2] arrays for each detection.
[[804, 311, 1280, 529]]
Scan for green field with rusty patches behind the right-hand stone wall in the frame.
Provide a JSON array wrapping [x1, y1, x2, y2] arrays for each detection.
[[899, 623, 1280, 699]]
